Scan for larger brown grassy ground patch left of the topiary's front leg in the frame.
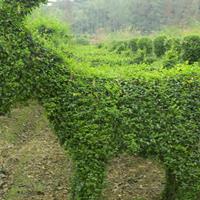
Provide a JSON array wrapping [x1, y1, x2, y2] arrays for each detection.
[[0, 105, 71, 200]]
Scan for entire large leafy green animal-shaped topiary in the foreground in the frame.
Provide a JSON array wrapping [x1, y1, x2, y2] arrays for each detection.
[[0, 0, 200, 200]]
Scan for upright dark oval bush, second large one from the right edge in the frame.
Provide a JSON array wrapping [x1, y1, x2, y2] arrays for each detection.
[[153, 36, 170, 57]]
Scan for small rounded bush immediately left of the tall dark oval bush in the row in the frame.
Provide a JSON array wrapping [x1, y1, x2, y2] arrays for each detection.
[[138, 37, 153, 55]]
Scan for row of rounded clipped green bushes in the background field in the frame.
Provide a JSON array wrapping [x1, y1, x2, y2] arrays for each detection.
[[110, 35, 200, 64]]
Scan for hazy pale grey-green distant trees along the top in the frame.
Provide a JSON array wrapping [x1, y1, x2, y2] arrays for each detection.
[[44, 0, 200, 34]]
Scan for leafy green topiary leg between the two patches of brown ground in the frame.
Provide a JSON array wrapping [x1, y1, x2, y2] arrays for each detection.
[[71, 157, 108, 200]]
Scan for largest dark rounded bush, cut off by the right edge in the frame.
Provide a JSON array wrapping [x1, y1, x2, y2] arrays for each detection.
[[182, 35, 200, 64]]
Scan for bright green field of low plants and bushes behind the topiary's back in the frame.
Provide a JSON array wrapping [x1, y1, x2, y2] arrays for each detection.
[[64, 35, 200, 80]]
